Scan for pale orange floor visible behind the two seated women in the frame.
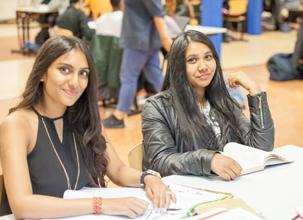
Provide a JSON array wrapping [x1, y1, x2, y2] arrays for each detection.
[[0, 22, 303, 168]]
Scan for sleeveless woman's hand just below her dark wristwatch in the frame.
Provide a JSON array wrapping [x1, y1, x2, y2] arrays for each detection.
[[144, 175, 176, 208]]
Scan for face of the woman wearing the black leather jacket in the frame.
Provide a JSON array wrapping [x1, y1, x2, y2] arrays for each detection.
[[185, 41, 217, 96]]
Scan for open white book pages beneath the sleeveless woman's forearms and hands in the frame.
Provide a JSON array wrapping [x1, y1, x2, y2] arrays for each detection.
[[52, 184, 226, 220]]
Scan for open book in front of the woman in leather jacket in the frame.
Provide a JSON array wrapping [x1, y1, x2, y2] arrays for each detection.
[[223, 142, 292, 175]]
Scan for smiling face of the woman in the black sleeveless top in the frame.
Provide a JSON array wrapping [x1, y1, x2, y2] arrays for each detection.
[[41, 49, 89, 108]]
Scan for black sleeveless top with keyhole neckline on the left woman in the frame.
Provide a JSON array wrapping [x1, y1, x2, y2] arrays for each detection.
[[0, 109, 89, 216]]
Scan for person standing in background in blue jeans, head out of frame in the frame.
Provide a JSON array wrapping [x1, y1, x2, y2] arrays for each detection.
[[103, 0, 172, 128]]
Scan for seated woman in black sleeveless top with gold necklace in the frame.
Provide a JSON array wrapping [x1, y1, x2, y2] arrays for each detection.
[[0, 37, 175, 218]]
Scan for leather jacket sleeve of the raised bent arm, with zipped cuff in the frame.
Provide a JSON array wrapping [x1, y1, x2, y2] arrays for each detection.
[[239, 92, 275, 151]]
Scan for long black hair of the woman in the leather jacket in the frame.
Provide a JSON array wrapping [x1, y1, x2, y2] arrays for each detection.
[[162, 30, 242, 150]]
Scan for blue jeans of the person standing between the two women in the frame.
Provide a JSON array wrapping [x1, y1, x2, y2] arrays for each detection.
[[117, 48, 163, 113]]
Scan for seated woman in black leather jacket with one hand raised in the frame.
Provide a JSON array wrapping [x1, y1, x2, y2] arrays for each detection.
[[142, 31, 274, 180]]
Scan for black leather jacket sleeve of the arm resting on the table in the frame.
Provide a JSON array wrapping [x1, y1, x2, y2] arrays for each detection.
[[142, 101, 216, 176]]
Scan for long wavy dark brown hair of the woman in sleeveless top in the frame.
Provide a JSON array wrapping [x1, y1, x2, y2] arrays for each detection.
[[10, 36, 108, 186]]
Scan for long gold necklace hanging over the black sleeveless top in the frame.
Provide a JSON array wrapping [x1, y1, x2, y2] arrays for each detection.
[[41, 117, 80, 190]]
